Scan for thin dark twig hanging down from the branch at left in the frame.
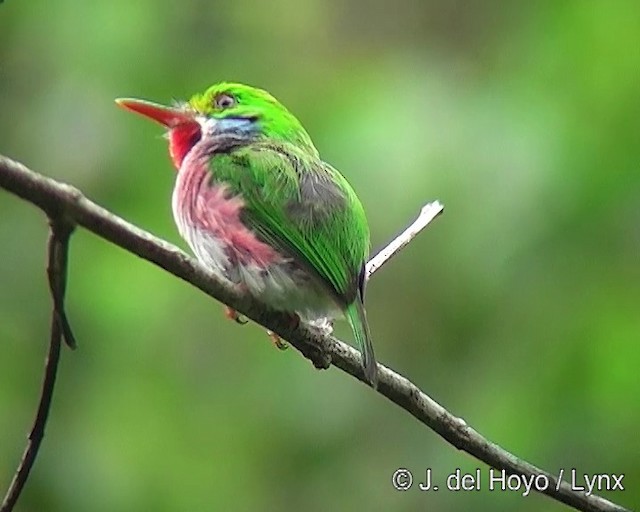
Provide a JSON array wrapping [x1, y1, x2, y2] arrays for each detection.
[[0, 220, 73, 512]]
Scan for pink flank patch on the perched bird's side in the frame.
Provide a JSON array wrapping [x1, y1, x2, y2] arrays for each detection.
[[176, 144, 284, 268]]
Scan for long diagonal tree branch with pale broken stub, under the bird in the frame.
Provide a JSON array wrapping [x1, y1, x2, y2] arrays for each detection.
[[0, 156, 626, 512]]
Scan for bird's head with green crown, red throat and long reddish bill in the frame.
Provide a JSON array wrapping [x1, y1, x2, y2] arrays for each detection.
[[116, 82, 318, 169]]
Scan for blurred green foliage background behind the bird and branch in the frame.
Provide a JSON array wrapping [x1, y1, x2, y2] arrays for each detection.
[[0, 0, 640, 512]]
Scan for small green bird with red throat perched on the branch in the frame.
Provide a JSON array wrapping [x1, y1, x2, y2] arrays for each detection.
[[116, 83, 377, 386]]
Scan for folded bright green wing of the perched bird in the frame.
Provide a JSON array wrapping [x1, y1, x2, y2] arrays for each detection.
[[211, 142, 369, 305]]
